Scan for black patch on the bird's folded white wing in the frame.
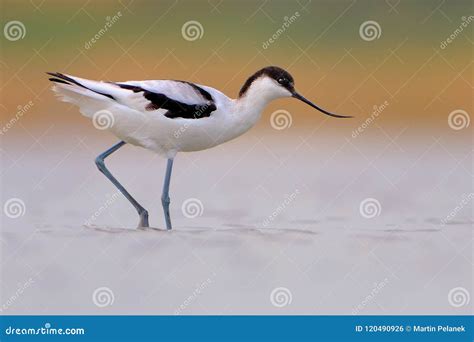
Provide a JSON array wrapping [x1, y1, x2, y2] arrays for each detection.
[[115, 82, 217, 119]]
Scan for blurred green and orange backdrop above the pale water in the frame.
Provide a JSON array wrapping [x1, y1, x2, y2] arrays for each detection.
[[1, 0, 472, 134]]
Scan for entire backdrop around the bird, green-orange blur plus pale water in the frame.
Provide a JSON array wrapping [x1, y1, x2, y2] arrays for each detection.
[[0, 0, 474, 314]]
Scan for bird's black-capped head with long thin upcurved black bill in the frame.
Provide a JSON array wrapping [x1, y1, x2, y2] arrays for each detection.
[[239, 66, 352, 118]]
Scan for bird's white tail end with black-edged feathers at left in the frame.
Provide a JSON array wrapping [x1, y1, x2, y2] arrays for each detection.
[[47, 72, 116, 117]]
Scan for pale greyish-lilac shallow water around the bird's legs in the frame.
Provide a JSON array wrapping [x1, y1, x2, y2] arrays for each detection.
[[0, 140, 473, 314]]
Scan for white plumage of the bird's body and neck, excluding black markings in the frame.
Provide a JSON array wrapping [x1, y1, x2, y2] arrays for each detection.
[[53, 74, 291, 158]]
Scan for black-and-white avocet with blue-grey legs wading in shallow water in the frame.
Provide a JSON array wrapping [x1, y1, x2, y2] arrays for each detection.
[[48, 66, 350, 229]]
